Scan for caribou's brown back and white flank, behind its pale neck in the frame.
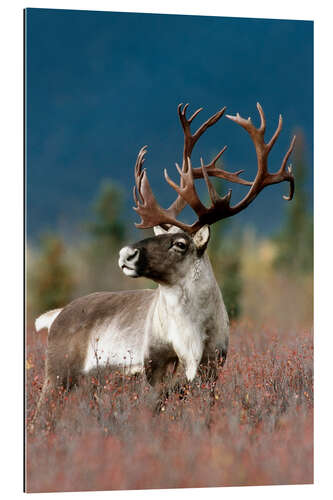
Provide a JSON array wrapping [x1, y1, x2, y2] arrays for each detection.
[[47, 290, 156, 384]]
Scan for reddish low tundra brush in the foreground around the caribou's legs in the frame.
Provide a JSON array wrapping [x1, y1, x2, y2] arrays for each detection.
[[26, 323, 313, 492]]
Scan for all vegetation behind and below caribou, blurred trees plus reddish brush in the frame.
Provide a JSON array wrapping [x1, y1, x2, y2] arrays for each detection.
[[26, 116, 313, 492]]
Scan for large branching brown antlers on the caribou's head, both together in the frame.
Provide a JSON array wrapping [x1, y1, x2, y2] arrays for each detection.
[[134, 103, 296, 233]]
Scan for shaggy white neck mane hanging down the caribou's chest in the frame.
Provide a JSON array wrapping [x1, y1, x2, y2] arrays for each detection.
[[153, 255, 223, 380]]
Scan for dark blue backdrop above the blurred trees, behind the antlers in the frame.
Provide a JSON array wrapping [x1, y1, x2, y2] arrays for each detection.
[[26, 9, 313, 240]]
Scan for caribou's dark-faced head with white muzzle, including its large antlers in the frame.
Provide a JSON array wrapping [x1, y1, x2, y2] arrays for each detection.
[[119, 103, 295, 284]]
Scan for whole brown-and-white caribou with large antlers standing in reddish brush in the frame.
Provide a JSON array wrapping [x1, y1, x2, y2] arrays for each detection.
[[35, 103, 295, 413]]
